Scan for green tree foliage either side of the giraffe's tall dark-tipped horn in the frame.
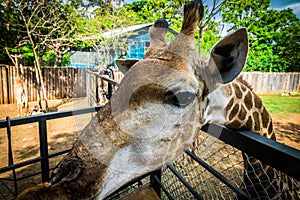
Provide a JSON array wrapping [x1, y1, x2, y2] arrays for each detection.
[[124, 0, 226, 55]]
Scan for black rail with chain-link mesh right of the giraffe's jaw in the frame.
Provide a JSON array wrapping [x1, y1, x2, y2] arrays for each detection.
[[158, 124, 300, 200]]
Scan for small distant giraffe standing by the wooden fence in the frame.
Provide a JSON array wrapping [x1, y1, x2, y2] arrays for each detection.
[[14, 76, 29, 117]]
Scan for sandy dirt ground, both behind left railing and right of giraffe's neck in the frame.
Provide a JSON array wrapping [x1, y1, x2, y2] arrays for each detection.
[[0, 98, 300, 200]]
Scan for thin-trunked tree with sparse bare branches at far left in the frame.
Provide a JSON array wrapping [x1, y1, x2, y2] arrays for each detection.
[[1, 0, 76, 110]]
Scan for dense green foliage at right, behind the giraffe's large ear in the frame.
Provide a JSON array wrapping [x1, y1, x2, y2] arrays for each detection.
[[222, 0, 300, 72]]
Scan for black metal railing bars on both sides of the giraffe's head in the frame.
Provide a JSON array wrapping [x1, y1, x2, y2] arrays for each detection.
[[0, 107, 300, 199]]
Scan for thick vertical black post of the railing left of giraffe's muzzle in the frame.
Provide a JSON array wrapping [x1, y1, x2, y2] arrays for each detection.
[[39, 117, 49, 182]]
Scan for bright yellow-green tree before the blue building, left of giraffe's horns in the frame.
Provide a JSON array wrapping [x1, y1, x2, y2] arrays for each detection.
[[76, 8, 135, 68]]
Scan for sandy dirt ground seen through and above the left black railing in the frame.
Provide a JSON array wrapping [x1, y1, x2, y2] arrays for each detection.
[[0, 98, 91, 200]]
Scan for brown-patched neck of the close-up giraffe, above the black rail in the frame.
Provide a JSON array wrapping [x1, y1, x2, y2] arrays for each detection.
[[202, 81, 276, 140]]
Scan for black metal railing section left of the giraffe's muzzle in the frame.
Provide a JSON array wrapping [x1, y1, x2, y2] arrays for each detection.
[[0, 106, 101, 197]]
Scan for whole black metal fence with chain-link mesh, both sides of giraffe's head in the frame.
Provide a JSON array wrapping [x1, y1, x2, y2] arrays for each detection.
[[0, 107, 300, 199]]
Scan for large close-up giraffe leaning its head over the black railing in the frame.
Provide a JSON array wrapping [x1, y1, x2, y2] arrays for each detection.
[[18, 1, 298, 200]]
